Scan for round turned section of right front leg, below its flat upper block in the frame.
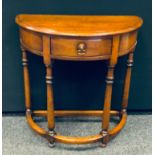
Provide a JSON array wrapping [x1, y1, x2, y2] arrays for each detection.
[[101, 65, 114, 147]]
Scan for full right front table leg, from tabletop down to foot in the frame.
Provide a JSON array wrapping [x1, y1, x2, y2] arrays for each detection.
[[101, 35, 120, 147]]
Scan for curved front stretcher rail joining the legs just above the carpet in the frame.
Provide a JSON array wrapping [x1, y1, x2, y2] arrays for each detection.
[[26, 112, 127, 144]]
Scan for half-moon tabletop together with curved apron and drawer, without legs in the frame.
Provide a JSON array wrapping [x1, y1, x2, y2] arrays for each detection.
[[16, 15, 143, 61]]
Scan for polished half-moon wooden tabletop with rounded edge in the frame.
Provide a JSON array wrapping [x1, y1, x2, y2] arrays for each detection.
[[16, 14, 143, 37]]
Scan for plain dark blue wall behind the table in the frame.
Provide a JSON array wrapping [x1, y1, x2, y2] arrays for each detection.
[[3, 0, 152, 112]]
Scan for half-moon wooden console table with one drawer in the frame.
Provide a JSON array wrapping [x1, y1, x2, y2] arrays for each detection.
[[16, 14, 143, 147]]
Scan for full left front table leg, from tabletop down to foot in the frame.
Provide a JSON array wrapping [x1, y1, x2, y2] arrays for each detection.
[[43, 35, 56, 147]]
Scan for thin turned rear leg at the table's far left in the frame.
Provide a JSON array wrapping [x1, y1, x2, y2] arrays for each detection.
[[21, 47, 31, 113]]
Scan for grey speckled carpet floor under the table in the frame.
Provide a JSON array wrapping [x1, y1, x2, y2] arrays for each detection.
[[2, 115, 152, 155]]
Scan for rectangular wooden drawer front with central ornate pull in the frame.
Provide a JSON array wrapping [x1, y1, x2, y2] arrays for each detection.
[[51, 37, 111, 58]]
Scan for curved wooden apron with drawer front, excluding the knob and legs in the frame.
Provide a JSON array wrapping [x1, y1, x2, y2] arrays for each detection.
[[20, 28, 137, 61]]
